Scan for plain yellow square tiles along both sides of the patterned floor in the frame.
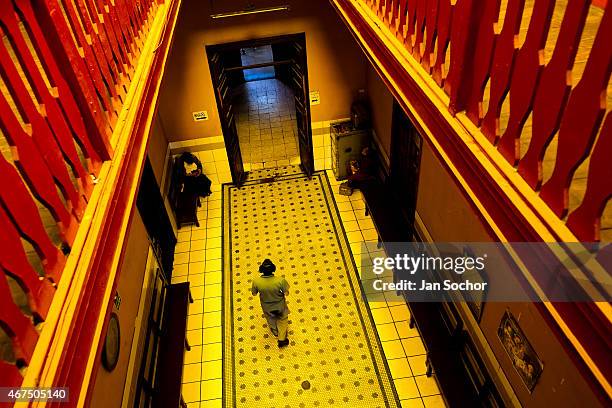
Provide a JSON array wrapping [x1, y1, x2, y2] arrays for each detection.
[[173, 163, 445, 408]]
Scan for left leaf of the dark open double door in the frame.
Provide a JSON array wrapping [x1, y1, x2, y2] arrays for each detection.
[[208, 52, 247, 186]]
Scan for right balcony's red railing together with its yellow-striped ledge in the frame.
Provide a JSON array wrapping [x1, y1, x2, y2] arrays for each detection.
[[330, 0, 612, 398]]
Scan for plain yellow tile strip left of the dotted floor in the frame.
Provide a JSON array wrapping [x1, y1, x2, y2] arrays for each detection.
[[172, 159, 230, 408]]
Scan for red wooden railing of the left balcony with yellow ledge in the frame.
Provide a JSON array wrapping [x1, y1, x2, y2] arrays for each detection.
[[0, 0, 180, 403]]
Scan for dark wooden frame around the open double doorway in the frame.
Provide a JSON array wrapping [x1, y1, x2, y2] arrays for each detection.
[[204, 32, 314, 181]]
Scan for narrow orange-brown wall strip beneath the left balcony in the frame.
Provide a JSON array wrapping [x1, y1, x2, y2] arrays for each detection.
[[90, 210, 149, 408]]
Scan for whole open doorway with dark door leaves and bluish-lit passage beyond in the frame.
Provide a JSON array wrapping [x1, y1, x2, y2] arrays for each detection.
[[206, 34, 314, 185]]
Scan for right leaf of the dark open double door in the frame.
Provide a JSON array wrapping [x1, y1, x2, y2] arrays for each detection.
[[290, 39, 314, 177]]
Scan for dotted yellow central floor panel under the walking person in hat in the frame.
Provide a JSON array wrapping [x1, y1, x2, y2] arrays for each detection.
[[223, 169, 398, 407]]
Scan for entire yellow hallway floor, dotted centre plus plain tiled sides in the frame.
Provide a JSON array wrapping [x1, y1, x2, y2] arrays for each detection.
[[173, 162, 444, 408]]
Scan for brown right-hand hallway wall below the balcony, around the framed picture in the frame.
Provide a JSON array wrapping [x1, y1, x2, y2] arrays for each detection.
[[360, 57, 602, 407]]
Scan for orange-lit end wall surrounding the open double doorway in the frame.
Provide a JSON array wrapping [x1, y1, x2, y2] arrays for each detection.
[[159, 0, 367, 142]]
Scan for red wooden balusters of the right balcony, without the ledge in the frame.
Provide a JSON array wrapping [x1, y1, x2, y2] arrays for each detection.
[[358, 0, 612, 241]]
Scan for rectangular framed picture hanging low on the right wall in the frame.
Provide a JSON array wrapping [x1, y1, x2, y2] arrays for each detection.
[[497, 311, 544, 392]]
